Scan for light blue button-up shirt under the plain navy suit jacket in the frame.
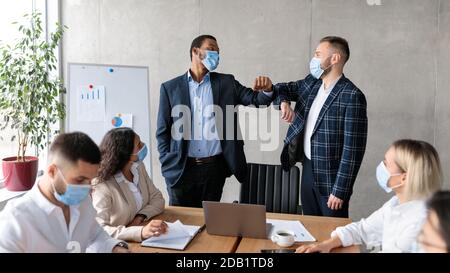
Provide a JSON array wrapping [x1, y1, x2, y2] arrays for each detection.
[[188, 71, 222, 157]]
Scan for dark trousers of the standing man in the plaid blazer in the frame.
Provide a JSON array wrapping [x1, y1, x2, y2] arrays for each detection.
[[301, 156, 348, 218]]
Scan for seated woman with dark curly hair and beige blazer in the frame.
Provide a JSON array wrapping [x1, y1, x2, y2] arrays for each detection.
[[92, 128, 167, 242]]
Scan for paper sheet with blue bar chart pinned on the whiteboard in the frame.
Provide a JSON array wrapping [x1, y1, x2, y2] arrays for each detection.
[[77, 85, 105, 122]]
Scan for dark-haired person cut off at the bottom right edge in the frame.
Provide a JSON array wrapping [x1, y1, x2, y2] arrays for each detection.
[[418, 191, 450, 253]]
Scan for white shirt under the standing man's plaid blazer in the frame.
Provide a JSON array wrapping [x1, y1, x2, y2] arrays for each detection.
[[303, 75, 342, 159]]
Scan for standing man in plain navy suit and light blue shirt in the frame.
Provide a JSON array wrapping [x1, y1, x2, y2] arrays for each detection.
[[156, 35, 276, 207]]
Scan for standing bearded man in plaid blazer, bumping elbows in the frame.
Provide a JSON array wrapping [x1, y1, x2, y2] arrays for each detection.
[[254, 36, 367, 217]]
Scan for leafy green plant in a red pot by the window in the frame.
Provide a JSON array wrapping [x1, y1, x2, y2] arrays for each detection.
[[0, 13, 66, 191]]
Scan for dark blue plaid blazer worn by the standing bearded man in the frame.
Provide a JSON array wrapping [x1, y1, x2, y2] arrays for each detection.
[[273, 75, 367, 201]]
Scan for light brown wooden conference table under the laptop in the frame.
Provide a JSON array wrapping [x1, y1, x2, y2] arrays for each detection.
[[129, 207, 359, 253]]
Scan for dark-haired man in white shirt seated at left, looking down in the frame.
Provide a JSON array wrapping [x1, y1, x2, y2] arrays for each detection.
[[0, 132, 128, 252]]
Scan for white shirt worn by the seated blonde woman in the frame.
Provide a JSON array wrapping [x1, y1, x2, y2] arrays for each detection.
[[331, 196, 427, 252]]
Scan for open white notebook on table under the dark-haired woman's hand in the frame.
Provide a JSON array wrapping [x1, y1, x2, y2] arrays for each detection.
[[141, 220, 201, 250]]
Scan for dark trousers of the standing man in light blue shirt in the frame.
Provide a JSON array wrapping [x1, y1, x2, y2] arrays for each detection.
[[167, 157, 227, 208]]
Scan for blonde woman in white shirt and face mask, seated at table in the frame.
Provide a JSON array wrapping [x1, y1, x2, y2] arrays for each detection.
[[297, 140, 442, 253]]
